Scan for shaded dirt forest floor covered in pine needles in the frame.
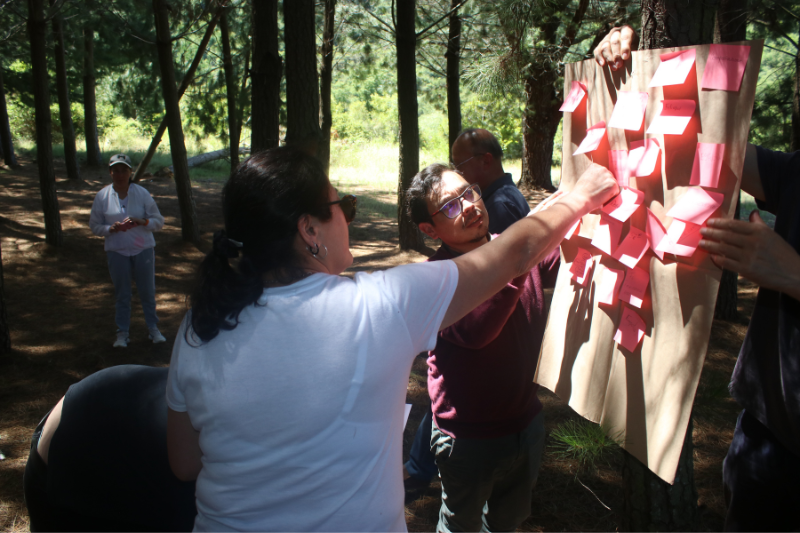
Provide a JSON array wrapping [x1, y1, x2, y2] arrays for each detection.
[[0, 157, 756, 531]]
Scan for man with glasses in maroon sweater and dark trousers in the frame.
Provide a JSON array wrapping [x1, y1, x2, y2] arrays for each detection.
[[407, 165, 560, 531]]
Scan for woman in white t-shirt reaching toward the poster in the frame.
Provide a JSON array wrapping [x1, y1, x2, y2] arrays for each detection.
[[161, 147, 616, 531]]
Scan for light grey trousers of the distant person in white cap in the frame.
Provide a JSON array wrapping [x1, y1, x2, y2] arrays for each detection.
[[106, 248, 158, 331]]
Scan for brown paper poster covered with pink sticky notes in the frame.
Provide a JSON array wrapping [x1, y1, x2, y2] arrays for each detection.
[[535, 41, 763, 483]]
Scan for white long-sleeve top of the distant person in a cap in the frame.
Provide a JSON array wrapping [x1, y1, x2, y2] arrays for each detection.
[[89, 183, 164, 256]]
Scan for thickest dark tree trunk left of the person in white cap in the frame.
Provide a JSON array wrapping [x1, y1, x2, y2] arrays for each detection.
[[28, 0, 62, 246]]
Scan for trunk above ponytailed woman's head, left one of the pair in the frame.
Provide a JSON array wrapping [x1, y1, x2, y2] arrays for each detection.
[[255, 0, 283, 153]]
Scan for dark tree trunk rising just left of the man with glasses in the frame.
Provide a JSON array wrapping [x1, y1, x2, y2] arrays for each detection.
[[395, 0, 424, 250]]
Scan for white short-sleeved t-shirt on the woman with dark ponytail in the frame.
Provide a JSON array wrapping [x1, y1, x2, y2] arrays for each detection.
[[167, 261, 458, 531]]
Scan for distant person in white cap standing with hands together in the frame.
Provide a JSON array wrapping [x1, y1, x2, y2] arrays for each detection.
[[89, 154, 167, 348]]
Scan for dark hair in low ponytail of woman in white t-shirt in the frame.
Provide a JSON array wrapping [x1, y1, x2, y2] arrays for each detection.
[[186, 147, 331, 342]]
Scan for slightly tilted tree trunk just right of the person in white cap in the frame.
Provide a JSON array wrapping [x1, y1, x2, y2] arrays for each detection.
[[153, 0, 200, 244]]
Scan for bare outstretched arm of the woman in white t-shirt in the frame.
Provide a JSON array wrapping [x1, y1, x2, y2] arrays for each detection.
[[440, 164, 619, 330]]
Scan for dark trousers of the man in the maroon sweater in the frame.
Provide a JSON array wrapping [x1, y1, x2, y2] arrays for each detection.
[[431, 412, 545, 532]]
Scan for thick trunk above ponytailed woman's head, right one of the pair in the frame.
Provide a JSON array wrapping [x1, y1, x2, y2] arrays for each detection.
[[283, 0, 321, 155]]
